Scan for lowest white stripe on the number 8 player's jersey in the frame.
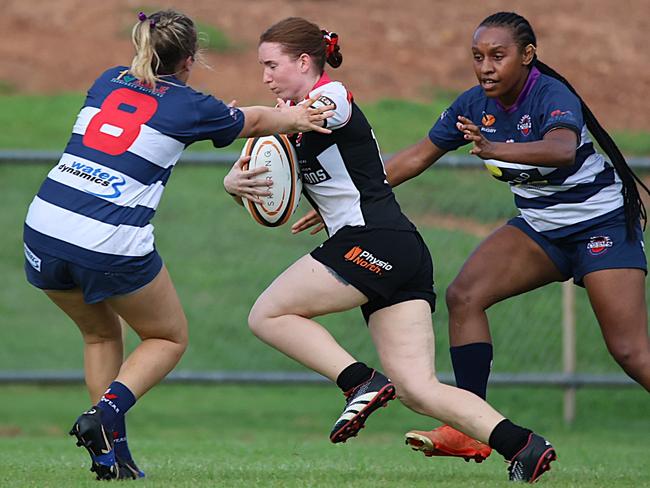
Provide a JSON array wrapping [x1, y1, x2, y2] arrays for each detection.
[[25, 197, 154, 257]]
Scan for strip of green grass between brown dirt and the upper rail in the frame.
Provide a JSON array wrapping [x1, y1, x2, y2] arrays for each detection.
[[0, 93, 650, 155]]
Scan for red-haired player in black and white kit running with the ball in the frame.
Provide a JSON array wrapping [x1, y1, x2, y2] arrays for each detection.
[[226, 18, 555, 481]]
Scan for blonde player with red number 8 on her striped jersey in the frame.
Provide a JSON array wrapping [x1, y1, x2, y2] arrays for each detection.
[[24, 10, 330, 480]]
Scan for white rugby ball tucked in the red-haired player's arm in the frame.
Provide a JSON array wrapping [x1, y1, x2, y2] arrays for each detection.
[[242, 134, 302, 227]]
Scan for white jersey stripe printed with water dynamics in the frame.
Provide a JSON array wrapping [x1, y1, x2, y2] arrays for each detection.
[[47, 153, 165, 210]]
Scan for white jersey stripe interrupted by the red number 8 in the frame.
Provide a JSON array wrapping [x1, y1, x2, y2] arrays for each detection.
[[72, 107, 185, 168]]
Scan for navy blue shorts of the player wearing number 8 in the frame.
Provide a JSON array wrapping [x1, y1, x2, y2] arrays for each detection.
[[24, 244, 162, 303]]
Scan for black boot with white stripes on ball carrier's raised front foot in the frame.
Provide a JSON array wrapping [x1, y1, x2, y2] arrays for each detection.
[[330, 370, 395, 443]]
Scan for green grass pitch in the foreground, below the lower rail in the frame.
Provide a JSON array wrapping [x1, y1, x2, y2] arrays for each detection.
[[0, 385, 650, 488]]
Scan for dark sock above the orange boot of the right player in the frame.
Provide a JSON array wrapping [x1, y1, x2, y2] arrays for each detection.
[[449, 342, 492, 400]]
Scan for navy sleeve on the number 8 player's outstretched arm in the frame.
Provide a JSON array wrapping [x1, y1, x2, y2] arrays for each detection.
[[192, 93, 244, 147]]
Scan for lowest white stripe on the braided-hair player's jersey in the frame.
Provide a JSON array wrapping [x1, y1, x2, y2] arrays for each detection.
[[519, 176, 623, 232]]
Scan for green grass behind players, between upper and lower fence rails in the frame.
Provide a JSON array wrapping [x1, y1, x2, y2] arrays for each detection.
[[0, 165, 640, 373]]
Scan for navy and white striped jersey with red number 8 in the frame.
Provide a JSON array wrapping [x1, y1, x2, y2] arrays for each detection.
[[25, 67, 244, 271]]
